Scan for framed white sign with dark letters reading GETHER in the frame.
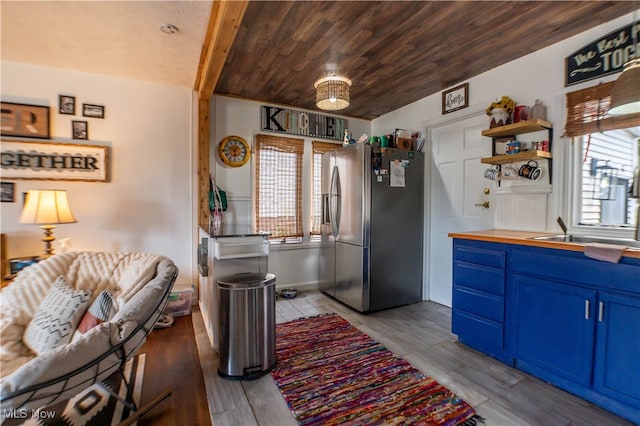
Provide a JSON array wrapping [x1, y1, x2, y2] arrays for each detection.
[[0, 140, 109, 182]]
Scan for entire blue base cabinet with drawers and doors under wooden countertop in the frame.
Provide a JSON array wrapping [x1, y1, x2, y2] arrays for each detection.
[[452, 238, 640, 424]]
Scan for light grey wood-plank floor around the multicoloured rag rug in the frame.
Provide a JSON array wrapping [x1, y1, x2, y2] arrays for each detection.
[[193, 292, 631, 426]]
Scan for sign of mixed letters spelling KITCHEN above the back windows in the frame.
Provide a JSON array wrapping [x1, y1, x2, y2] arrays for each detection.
[[260, 105, 348, 141]]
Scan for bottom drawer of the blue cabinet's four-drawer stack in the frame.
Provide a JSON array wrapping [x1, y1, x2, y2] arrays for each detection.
[[451, 309, 503, 352]]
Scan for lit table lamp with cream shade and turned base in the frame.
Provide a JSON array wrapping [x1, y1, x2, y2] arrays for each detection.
[[20, 189, 77, 258]]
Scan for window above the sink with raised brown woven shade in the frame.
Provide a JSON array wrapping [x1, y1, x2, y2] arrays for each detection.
[[563, 82, 640, 228]]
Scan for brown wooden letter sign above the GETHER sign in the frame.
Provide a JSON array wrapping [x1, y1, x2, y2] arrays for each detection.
[[0, 102, 49, 139]]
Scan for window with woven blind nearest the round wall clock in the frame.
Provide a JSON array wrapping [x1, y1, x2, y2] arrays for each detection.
[[255, 135, 304, 239]]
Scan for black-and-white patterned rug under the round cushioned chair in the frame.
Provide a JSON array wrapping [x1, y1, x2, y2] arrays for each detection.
[[2, 354, 146, 426]]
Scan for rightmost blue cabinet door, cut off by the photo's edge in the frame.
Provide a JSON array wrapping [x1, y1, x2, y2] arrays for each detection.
[[593, 292, 640, 407]]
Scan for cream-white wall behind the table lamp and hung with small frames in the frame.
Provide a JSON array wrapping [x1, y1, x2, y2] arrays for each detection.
[[1, 61, 197, 285]]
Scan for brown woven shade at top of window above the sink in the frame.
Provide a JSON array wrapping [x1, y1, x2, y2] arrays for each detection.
[[562, 82, 640, 137]]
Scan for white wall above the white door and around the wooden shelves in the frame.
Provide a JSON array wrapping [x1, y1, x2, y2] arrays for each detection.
[[372, 14, 633, 235]]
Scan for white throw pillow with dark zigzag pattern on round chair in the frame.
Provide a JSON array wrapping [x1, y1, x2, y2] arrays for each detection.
[[22, 276, 91, 355]]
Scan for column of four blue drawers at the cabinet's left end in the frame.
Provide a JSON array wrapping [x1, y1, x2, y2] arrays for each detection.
[[451, 239, 512, 364]]
